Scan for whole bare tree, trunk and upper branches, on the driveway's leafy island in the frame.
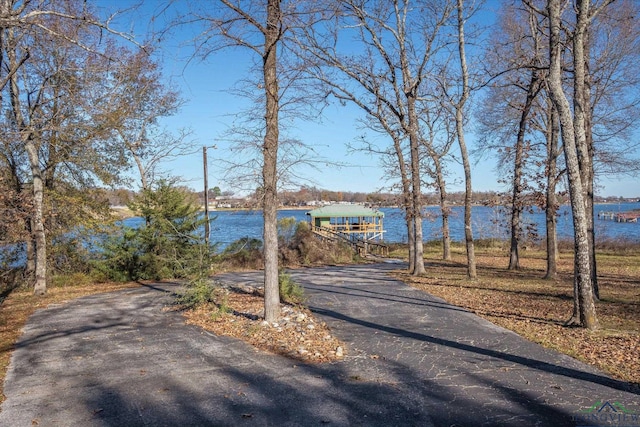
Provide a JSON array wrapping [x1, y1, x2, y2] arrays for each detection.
[[183, 0, 295, 322]]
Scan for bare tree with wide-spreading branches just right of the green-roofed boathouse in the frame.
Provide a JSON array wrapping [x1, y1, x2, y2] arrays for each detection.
[[300, 0, 452, 275]]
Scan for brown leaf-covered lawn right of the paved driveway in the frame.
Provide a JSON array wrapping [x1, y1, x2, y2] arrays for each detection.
[[396, 244, 640, 386]]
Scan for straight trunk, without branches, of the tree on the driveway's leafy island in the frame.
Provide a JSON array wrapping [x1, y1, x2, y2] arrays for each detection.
[[262, 0, 281, 322]]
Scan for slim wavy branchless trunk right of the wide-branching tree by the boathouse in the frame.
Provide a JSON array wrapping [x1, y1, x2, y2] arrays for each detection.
[[455, 0, 478, 279]]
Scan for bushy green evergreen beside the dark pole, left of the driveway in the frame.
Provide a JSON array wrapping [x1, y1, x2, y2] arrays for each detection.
[[97, 181, 211, 281]]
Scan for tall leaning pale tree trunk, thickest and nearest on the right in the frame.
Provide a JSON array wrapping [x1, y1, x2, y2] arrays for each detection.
[[547, 0, 598, 329]]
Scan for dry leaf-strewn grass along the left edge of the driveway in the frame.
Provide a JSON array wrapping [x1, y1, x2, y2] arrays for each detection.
[[0, 283, 138, 403]]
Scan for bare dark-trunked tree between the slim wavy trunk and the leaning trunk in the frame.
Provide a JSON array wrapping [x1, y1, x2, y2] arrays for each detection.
[[478, 5, 545, 270]]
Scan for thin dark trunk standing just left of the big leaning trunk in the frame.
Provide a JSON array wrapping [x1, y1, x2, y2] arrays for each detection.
[[545, 100, 560, 280]]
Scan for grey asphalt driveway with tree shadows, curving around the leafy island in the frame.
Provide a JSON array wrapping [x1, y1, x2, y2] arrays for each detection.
[[0, 264, 640, 426]]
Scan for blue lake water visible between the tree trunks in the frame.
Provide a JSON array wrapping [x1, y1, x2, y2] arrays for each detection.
[[125, 203, 640, 248]]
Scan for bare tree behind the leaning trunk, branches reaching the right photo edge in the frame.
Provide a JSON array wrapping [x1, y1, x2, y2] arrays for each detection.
[[573, 1, 640, 298]]
